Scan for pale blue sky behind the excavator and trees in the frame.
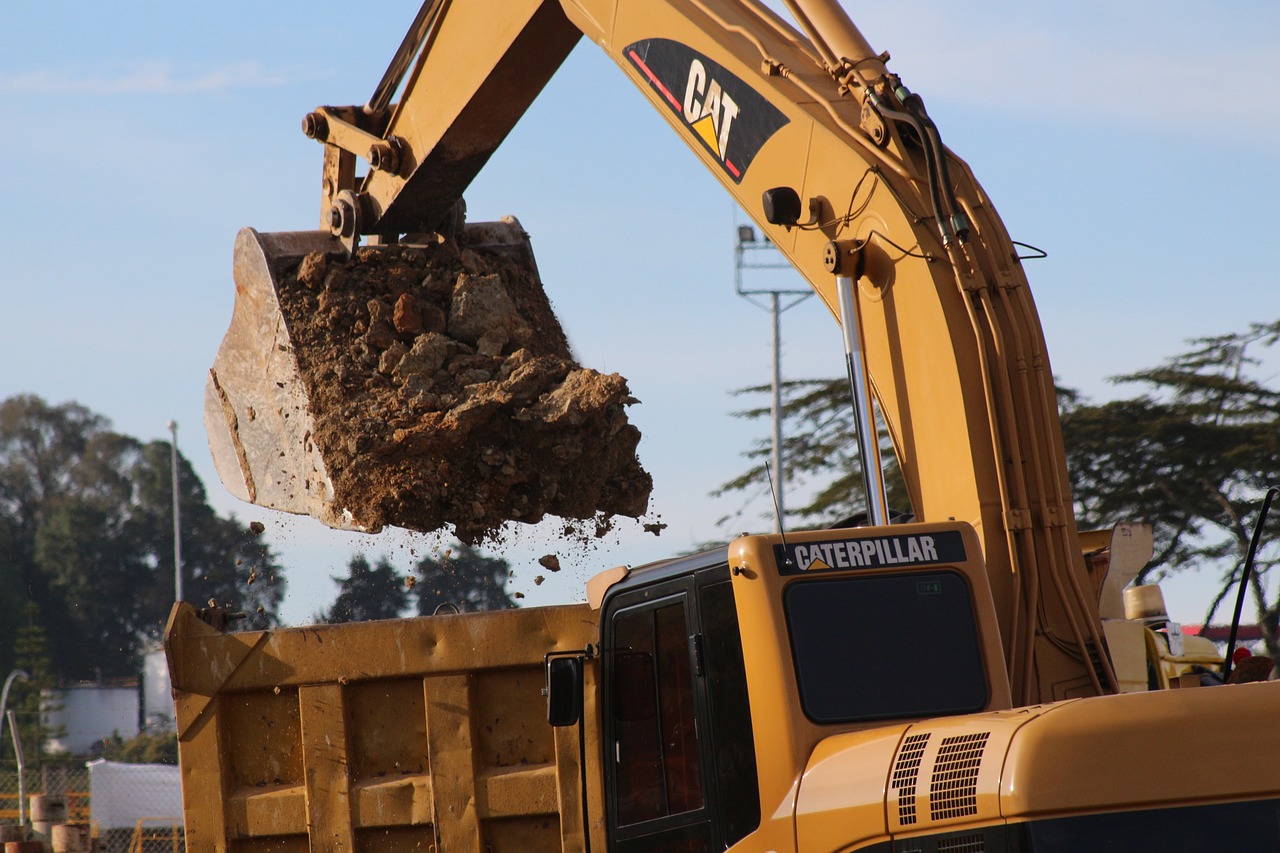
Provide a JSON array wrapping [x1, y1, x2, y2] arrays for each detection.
[[0, 0, 1280, 621]]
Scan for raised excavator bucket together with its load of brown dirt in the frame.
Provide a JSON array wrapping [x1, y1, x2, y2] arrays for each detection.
[[205, 218, 652, 542]]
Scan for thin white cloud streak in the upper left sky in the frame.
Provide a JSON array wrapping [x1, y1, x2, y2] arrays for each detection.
[[0, 61, 293, 97]]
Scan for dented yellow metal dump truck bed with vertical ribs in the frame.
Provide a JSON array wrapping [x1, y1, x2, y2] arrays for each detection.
[[165, 605, 603, 853]]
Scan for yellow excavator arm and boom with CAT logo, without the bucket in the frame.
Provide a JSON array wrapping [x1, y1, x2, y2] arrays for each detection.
[[230, 0, 1115, 704]]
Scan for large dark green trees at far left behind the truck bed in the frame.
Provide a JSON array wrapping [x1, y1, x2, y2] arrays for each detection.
[[0, 396, 283, 681]]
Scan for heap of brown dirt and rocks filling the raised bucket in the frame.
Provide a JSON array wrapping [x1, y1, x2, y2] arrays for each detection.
[[278, 230, 653, 544]]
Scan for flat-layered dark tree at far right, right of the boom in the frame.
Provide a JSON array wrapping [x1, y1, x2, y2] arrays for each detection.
[[1062, 321, 1280, 654]]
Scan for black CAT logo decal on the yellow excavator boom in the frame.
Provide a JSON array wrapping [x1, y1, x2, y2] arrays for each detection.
[[623, 38, 790, 183]]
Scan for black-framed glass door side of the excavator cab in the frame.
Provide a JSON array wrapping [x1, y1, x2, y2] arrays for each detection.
[[602, 566, 759, 853]]
